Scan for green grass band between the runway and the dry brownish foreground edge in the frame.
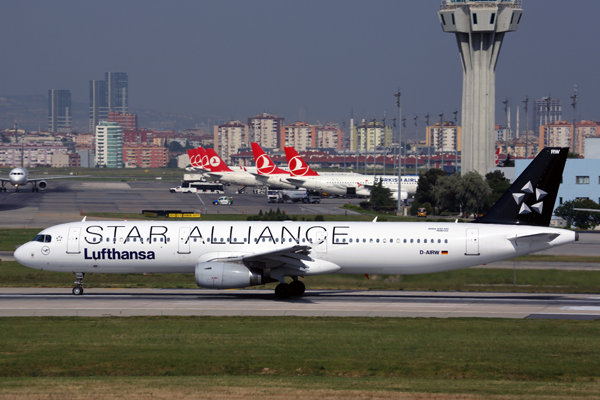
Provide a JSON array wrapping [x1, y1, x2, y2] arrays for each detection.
[[0, 317, 600, 382]]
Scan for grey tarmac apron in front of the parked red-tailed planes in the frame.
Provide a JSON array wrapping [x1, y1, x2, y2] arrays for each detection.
[[0, 181, 359, 228]]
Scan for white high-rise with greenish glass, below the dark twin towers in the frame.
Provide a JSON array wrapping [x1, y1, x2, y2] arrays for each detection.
[[96, 121, 123, 168]]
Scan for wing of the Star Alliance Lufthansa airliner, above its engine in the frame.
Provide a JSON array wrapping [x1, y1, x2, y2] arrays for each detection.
[[203, 245, 314, 271]]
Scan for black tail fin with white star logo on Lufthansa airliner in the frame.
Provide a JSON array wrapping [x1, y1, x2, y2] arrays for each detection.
[[474, 147, 569, 226]]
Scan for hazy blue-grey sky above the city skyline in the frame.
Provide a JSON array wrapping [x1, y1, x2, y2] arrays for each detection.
[[0, 0, 600, 128]]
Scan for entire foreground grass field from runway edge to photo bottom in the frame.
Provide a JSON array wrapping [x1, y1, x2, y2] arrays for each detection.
[[0, 317, 600, 398]]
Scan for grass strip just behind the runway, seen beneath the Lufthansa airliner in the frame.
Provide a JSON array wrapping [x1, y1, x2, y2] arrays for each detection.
[[0, 261, 600, 293]]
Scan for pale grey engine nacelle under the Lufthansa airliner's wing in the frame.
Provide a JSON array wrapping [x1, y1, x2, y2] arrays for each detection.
[[196, 262, 274, 289]]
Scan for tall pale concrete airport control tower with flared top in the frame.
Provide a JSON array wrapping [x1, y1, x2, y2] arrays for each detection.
[[438, 0, 523, 175]]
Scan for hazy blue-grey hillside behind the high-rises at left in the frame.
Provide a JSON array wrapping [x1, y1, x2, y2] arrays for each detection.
[[0, 96, 223, 132]]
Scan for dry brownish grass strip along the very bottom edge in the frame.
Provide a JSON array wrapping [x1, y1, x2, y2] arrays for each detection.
[[0, 375, 600, 400]]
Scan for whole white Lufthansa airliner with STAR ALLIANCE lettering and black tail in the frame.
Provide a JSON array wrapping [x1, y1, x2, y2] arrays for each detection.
[[14, 148, 578, 299]]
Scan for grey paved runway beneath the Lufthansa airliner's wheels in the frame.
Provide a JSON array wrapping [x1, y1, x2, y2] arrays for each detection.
[[0, 288, 600, 320]]
